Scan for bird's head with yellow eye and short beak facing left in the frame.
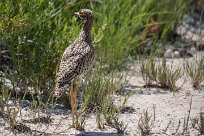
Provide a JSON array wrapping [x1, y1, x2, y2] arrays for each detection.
[[74, 9, 93, 23]]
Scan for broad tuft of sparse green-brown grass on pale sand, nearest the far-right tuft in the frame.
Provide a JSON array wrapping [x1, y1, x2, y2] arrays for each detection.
[[140, 57, 181, 91]]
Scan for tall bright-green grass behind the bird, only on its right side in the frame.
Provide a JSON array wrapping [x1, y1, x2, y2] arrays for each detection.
[[95, 0, 186, 68]]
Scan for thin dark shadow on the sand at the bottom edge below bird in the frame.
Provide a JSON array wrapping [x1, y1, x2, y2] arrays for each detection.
[[76, 132, 125, 136]]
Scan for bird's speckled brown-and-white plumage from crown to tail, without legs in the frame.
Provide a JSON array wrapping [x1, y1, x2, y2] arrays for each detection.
[[55, 9, 95, 95]]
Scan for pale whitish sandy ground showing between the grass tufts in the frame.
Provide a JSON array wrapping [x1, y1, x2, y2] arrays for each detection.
[[0, 53, 204, 136]]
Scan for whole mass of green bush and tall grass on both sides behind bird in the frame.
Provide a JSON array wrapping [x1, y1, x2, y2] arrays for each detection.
[[0, 0, 186, 95]]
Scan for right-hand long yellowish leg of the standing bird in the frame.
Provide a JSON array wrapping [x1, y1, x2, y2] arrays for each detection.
[[74, 78, 80, 129]]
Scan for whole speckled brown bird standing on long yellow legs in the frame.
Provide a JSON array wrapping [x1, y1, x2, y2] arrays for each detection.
[[55, 9, 95, 129]]
